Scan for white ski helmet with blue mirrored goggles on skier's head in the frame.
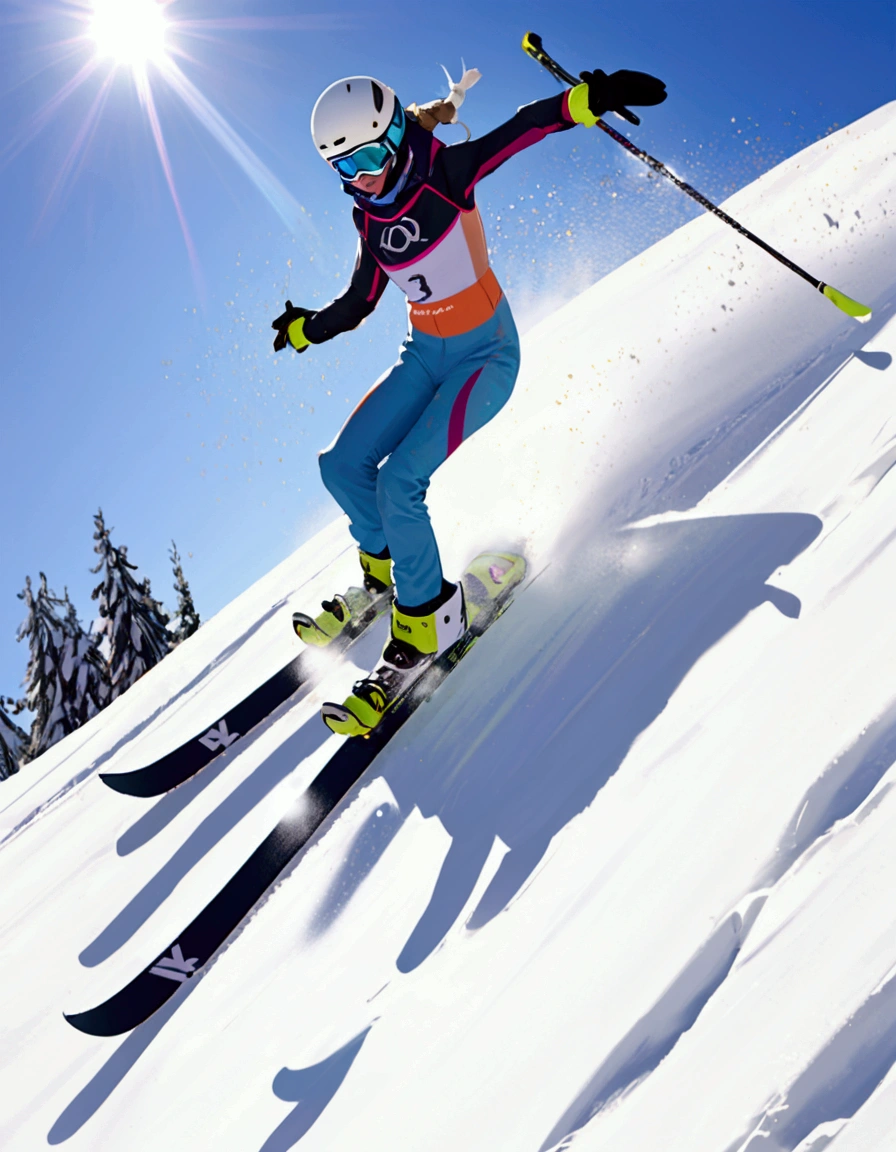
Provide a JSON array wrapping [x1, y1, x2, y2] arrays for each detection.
[[311, 76, 405, 181]]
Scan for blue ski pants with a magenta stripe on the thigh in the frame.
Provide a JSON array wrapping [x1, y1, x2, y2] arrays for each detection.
[[319, 297, 519, 608]]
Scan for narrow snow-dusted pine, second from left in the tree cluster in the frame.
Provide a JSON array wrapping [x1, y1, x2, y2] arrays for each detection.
[[16, 573, 71, 760]]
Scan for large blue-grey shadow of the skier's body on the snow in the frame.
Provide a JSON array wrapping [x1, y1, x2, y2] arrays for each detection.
[[384, 514, 821, 972]]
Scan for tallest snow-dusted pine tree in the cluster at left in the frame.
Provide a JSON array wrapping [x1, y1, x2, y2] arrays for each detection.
[[91, 508, 170, 700]]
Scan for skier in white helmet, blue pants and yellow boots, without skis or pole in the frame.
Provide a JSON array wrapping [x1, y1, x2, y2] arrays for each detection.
[[272, 69, 666, 734]]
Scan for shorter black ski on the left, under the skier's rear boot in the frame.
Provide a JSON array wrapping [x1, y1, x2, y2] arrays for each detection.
[[99, 591, 392, 797]]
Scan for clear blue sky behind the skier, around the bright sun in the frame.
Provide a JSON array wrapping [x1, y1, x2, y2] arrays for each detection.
[[0, 0, 896, 695]]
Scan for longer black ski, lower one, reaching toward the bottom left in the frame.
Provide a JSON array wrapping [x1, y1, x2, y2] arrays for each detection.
[[66, 581, 522, 1036]]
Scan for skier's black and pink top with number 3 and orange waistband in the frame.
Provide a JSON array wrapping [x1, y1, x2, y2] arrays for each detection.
[[304, 92, 574, 344]]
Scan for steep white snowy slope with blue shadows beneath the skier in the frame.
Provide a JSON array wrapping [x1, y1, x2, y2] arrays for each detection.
[[0, 104, 896, 1152]]
